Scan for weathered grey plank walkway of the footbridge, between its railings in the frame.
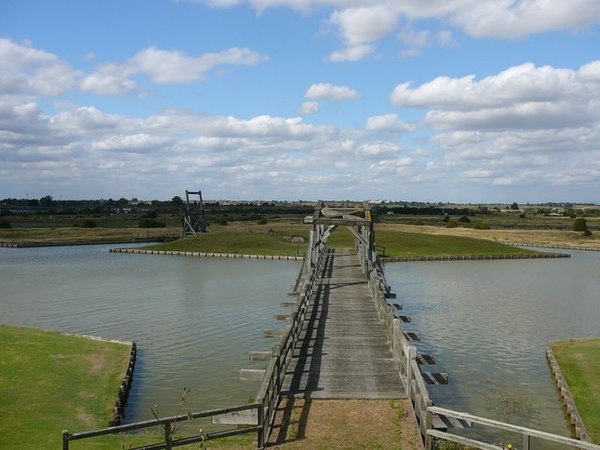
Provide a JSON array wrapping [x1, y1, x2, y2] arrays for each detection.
[[282, 250, 406, 399]]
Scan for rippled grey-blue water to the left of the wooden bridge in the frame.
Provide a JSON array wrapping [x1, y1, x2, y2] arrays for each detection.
[[0, 246, 300, 421]]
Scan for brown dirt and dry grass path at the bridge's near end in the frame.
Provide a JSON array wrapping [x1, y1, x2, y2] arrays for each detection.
[[271, 399, 423, 450]]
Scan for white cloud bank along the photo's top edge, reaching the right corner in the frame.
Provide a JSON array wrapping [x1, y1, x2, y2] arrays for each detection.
[[193, 0, 600, 61]]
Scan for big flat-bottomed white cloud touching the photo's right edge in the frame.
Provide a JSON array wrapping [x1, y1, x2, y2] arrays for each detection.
[[390, 62, 600, 130]]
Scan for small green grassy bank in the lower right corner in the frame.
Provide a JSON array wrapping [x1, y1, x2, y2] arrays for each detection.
[[552, 339, 600, 444]]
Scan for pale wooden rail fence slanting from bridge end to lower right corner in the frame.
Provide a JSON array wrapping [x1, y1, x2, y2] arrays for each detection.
[[427, 406, 600, 450]]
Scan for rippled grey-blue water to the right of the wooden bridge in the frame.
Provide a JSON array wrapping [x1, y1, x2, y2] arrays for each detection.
[[385, 252, 600, 442]]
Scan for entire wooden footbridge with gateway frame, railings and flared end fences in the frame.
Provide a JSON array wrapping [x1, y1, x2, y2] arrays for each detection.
[[63, 204, 600, 450]]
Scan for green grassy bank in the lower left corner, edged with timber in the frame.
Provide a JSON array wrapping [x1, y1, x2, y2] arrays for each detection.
[[0, 325, 148, 449]]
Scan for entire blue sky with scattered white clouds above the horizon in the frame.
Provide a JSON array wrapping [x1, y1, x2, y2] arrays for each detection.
[[0, 0, 600, 203]]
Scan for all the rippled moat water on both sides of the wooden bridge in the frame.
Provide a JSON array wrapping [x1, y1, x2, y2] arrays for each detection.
[[0, 245, 600, 442]]
